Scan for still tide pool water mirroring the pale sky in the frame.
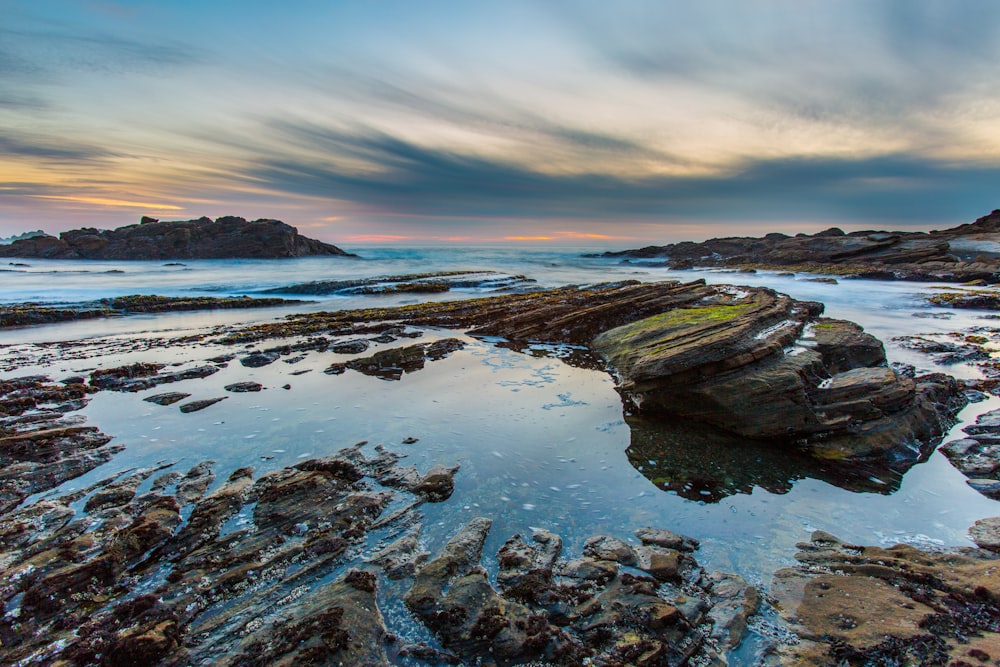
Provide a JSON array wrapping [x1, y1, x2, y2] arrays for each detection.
[[19, 332, 997, 581]]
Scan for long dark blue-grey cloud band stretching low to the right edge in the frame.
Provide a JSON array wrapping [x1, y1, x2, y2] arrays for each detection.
[[230, 121, 1000, 224]]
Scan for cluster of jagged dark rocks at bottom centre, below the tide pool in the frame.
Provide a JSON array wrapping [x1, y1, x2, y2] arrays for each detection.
[[405, 518, 758, 665]]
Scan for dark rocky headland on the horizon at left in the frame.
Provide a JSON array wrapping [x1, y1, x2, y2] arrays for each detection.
[[0, 216, 355, 260]]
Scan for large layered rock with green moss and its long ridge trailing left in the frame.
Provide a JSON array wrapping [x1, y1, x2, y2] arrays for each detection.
[[236, 281, 965, 462]]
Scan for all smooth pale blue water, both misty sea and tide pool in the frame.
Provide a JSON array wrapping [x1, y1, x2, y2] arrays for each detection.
[[0, 248, 1000, 656]]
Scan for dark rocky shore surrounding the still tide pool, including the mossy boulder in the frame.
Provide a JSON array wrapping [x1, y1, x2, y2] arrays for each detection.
[[0, 281, 1000, 665]]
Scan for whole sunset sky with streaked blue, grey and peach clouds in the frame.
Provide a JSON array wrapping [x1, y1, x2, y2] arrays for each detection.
[[0, 0, 1000, 247]]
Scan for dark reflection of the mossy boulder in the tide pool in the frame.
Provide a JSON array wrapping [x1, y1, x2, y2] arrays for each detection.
[[625, 416, 929, 503]]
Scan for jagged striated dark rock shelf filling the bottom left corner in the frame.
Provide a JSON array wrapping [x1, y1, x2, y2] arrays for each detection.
[[0, 448, 457, 665]]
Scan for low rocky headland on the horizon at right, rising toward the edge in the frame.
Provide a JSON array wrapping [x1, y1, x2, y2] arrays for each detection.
[[599, 209, 1000, 283]]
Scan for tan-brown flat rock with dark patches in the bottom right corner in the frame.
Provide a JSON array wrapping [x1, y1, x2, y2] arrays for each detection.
[[771, 532, 1000, 666]]
